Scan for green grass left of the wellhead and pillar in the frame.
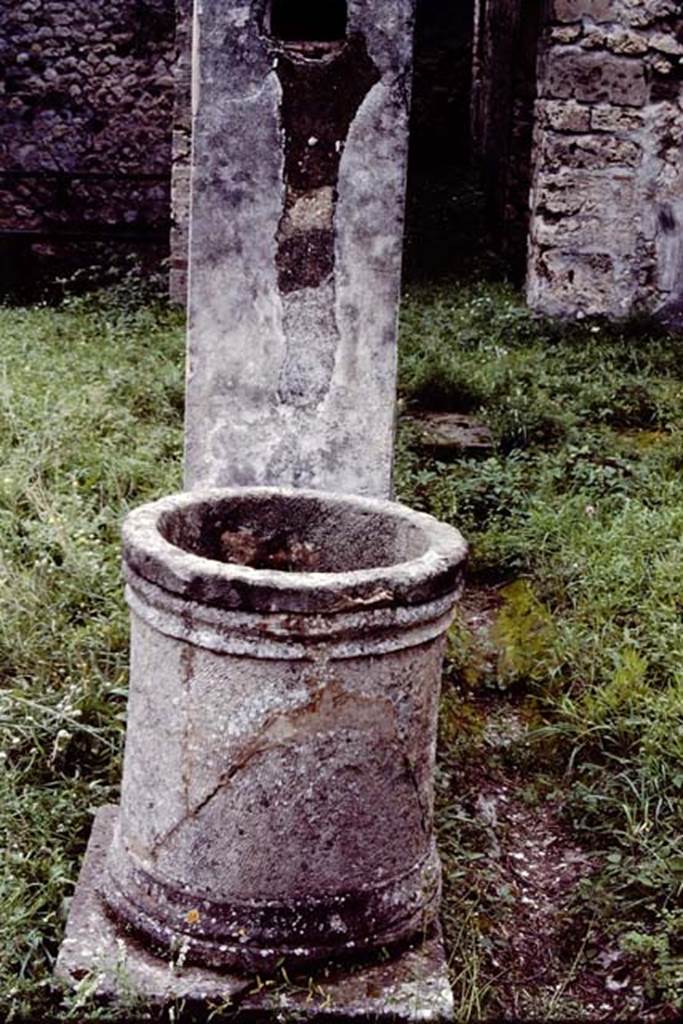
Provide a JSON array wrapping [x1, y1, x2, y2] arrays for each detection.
[[0, 284, 183, 1020]]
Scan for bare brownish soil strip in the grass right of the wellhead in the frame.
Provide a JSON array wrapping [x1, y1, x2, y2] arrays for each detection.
[[444, 587, 674, 1021]]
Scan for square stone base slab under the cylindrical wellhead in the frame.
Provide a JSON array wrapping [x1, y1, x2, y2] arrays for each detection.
[[55, 806, 454, 1024]]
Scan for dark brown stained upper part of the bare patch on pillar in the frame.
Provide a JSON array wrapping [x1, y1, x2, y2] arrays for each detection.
[[276, 33, 380, 294]]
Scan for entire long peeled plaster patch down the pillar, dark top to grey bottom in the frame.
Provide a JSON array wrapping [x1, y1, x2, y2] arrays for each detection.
[[276, 34, 380, 407]]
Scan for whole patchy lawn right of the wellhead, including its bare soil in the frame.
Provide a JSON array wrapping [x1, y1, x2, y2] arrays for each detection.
[[398, 286, 683, 1021]]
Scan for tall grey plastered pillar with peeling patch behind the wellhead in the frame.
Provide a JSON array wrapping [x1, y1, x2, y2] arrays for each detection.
[[185, 0, 413, 497]]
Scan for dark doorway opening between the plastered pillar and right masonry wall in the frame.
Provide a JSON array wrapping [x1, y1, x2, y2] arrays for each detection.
[[404, 0, 543, 284]]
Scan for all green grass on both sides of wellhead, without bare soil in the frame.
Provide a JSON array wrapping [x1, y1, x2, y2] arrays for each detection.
[[0, 276, 683, 1020]]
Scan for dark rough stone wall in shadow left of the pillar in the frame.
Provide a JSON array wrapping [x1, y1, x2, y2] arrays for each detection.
[[0, 0, 174, 296]]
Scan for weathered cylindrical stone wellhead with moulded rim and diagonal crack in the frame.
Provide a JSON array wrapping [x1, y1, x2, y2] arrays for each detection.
[[101, 487, 467, 972]]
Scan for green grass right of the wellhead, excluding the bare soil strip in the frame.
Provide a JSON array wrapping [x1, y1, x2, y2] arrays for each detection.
[[398, 286, 683, 1008]]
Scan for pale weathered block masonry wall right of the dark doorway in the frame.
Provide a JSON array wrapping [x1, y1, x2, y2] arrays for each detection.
[[527, 0, 683, 316]]
